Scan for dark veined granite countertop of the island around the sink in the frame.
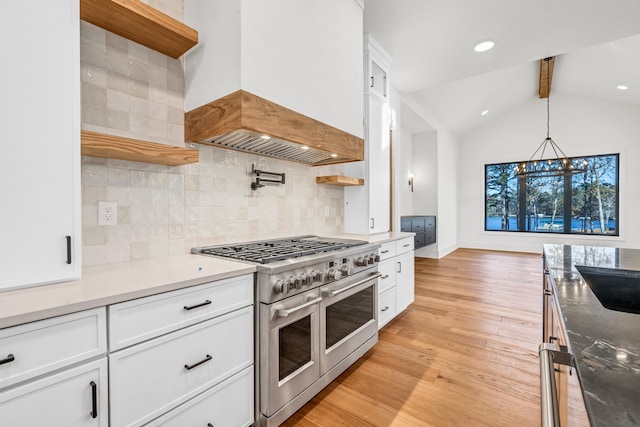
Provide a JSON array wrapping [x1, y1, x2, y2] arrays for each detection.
[[544, 244, 640, 427]]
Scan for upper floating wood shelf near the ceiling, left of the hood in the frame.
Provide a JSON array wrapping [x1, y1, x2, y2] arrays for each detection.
[[80, 0, 198, 58]]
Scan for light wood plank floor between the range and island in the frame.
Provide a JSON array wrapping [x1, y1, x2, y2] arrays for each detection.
[[284, 249, 542, 427]]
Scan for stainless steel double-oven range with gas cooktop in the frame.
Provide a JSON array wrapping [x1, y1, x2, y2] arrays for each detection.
[[193, 236, 379, 426]]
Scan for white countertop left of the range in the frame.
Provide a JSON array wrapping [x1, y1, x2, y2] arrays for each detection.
[[0, 254, 256, 329]]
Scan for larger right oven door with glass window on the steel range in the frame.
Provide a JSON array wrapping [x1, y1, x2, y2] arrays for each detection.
[[320, 272, 380, 375]]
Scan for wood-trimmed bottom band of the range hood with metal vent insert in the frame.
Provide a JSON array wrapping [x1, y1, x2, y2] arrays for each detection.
[[184, 90, 364, 166]]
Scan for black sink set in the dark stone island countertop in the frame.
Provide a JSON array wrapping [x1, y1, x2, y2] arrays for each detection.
[[576, 265, 640, 314]]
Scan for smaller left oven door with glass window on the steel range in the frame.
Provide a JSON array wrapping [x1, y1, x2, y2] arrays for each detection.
[[260, 291, 321, 417]]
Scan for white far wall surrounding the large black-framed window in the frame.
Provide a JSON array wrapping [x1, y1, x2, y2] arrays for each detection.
[[458, 92, 640, 252]]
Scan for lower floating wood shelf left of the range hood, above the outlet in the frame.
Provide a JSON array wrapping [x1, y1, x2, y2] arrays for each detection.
[[80, 130, 200, 166]]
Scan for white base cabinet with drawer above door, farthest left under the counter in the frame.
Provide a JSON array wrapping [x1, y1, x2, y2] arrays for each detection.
[[0, 307, 109, 427]]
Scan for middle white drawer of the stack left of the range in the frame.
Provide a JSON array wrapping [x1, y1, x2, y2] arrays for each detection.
[[109, 307, 253, 427]]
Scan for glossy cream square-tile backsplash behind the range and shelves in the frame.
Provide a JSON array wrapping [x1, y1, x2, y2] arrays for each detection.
[[81, 0, 344, 265]]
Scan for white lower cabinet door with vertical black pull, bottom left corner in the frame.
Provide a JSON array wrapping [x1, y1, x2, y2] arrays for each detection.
[[0, 357, 109, 427]]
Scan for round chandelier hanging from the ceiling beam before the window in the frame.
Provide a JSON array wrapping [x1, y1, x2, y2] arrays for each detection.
[[515, 58, 587, 178]]
